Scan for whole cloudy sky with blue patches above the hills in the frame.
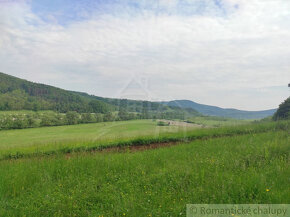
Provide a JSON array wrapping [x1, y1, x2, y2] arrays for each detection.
[[0, 0, 290, 110]]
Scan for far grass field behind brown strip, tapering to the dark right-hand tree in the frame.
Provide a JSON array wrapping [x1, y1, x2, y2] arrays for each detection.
[[0, 120, 286, 159]]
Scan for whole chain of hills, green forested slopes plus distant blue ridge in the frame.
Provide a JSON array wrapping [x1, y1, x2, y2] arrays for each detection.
[[0, 72, 278, 119]]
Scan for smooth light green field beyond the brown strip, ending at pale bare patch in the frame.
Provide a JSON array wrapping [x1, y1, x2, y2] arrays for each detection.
[[0, 120, 196, 156]]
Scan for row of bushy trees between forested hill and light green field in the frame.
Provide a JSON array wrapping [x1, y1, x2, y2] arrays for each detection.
[[0, 109, 188, 130]]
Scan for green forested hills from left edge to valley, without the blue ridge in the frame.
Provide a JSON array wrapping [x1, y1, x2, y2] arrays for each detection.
[[0, 72, 199, 118]]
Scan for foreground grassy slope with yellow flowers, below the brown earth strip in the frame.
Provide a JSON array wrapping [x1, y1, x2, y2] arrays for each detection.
[[0, 128, 290, 216]]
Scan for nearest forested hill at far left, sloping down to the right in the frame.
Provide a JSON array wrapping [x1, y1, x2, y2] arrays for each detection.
[[0, 73, 113, 113]]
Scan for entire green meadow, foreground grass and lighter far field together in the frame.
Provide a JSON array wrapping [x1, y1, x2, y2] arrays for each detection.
[[0, 120, 290, 217]]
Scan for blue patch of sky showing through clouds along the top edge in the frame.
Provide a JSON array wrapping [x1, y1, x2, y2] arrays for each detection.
[[30, 0, 232, 25]]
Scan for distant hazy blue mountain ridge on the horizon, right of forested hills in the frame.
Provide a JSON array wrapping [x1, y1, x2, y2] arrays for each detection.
[[162, 100, 277, 119]]
